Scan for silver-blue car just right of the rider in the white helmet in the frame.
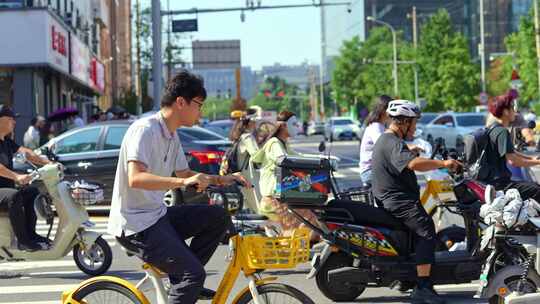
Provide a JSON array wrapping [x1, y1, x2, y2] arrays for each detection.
[[422, 112, 486, 149]]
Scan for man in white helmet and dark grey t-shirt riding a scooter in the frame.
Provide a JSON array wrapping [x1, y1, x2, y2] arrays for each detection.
[[372, 100, 462, 304]]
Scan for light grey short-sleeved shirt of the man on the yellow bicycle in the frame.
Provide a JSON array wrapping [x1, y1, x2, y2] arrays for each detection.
[[108, 112, 189, 236]]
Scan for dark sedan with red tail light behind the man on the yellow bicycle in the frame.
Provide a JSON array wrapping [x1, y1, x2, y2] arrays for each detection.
[[15, 120, 231, 205]]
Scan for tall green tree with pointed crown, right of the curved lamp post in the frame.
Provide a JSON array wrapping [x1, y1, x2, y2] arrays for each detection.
[[417, 9, 480, 111]]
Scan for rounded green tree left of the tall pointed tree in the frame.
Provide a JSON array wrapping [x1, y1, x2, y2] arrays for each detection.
[[332, 27, 414, 108]]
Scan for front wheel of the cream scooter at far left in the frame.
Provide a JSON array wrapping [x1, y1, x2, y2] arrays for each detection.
[[73, 236, 112, 276]]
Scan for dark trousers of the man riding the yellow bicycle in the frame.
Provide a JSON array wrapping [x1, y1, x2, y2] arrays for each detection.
[[118, 205, 232, 304]]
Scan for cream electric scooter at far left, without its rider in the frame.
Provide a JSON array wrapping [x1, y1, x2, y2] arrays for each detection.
[[0, 154, 112, 276]]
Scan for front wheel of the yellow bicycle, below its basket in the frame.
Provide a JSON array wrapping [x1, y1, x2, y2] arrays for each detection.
[[236, 284, 315, 304]]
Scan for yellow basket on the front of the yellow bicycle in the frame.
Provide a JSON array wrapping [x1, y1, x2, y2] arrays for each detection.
[[241, 228, 310, 269]]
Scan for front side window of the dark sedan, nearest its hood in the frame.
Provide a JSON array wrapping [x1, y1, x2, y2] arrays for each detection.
[[55, 128, 101, 154]]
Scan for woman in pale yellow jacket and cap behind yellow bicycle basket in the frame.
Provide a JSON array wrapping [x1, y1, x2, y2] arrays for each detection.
[[252, 111, 318, 240]]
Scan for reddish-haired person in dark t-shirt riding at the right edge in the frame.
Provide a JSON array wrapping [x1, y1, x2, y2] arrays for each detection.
[[481, 94, 540, 202]]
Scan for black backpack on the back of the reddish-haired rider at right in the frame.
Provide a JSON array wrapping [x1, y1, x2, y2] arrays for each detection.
[[463, 125, 496, 180]]
